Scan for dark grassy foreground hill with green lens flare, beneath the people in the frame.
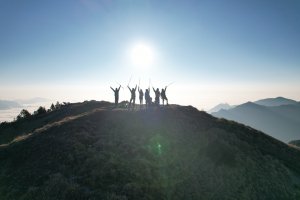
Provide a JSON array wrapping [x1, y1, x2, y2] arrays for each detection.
[[0, 102, 300, 200]]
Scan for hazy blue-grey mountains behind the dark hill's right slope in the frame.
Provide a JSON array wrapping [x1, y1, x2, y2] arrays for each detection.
[[212, 97, 300, 142]]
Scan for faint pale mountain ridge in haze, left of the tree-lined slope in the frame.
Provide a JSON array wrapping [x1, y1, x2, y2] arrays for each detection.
[[0, 97, 50, 110]]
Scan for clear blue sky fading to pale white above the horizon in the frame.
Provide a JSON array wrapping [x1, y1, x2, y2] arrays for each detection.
[[0, 0, 300, 110]]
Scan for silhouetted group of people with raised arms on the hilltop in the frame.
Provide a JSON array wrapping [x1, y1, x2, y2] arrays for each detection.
[[110, 85, 169, 108]]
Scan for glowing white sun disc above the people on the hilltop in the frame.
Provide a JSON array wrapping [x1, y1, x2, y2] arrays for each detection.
[[130, 43, 154, 68]]
